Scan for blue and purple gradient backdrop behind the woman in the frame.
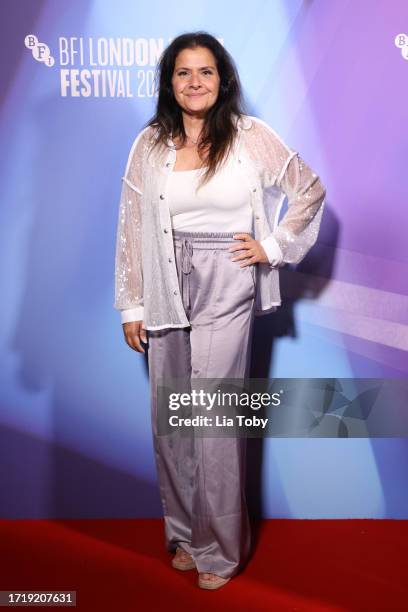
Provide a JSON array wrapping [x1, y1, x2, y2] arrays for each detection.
[[0, 0, 408, 518]]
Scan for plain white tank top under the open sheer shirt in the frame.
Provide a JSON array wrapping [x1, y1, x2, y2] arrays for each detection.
[[168, 155, 253, 233]]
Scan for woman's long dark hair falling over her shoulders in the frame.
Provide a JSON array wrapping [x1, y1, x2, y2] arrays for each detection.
[[145, 31, 245, 185]]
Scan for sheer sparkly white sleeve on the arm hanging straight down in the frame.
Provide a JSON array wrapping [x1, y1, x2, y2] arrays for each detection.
[[114, 127, 144, 323]]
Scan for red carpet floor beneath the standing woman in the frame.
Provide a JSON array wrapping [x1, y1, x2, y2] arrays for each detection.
[[0, 519, 408, 612]]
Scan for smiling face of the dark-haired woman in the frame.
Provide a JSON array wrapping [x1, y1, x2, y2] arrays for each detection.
[[171, 47, 220, 116]]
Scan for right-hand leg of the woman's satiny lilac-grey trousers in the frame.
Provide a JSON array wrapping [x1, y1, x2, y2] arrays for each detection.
[[190, 241, 255, 577]]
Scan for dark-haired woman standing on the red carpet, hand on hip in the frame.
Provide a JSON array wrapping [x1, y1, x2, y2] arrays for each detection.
[[114, 32, 325, 589]]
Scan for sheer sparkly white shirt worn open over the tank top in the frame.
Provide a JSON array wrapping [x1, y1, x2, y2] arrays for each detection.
[[114, 115, 326, 330]]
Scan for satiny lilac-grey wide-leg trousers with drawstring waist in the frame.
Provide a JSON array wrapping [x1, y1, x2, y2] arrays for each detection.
[[147, 230, 257, 577]]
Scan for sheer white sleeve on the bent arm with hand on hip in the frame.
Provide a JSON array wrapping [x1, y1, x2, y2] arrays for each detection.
[[253, 120, 326, 265]]
